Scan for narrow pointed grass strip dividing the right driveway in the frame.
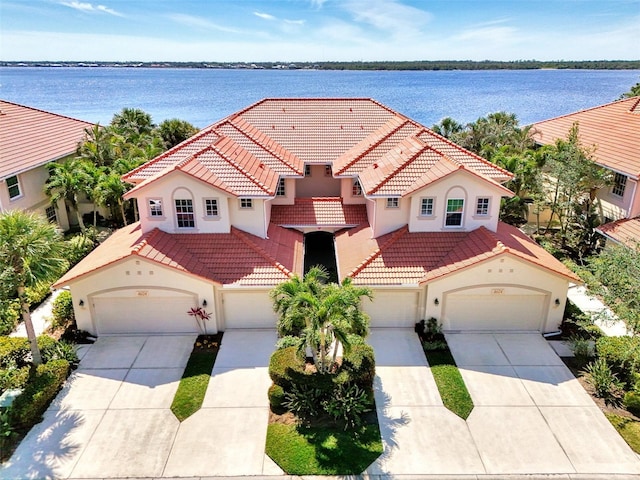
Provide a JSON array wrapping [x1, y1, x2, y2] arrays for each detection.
[[424, 348, 473, 420]]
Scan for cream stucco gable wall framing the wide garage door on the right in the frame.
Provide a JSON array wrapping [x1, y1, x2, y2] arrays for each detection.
[[423, 254, 569, 332]]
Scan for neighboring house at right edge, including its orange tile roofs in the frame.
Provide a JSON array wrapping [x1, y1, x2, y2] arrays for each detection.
[[533, 97, 640, 245]]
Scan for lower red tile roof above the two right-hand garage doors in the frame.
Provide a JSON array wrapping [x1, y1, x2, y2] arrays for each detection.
[[336, 223, 580, 285]]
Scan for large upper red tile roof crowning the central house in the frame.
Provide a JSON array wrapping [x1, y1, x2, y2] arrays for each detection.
[[123, 98, 512, 197]]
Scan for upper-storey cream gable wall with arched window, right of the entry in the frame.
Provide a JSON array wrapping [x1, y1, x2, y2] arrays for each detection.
[[409, 170, 503, 232]]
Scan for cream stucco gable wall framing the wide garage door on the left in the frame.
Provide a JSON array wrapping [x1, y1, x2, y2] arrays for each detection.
[[69, 257, 218, 335]]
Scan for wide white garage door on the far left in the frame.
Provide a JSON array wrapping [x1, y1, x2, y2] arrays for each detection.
[[92, 290, 200, 334]]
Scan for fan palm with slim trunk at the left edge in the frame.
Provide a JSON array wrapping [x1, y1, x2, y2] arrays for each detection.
[[0, 210, 68, 365]]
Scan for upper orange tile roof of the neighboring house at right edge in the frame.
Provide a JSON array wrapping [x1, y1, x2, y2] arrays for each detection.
[[534, 97, 640, 179]]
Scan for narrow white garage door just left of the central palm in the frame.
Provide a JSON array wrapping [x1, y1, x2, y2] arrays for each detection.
[[222, 291, 277, 329]]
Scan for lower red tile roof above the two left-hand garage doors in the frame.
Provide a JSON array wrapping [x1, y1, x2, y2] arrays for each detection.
[[55, 223, 303, 287]]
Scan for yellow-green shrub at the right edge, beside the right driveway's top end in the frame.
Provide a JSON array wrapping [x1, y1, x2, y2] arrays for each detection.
[[596, 337, 640, 386]]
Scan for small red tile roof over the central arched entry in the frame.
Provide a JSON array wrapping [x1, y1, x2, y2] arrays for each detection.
[[271, 197, 367, 227]]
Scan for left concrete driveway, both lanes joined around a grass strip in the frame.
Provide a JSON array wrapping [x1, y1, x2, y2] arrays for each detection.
[[0, 330, 282, 479]]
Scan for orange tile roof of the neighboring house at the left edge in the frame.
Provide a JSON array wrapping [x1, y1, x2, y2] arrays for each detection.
[[0, 100, 93, 180]]
